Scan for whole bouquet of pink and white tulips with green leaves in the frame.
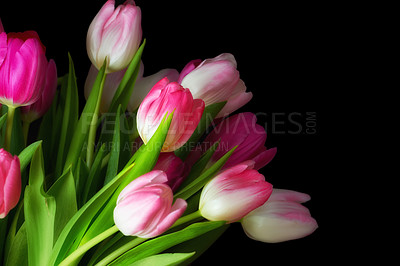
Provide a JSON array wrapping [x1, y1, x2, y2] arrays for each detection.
[[0, 0, 317, 265]]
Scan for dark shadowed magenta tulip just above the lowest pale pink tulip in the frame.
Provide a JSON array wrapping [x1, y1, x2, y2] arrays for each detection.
[[154, 152, 189, 191]]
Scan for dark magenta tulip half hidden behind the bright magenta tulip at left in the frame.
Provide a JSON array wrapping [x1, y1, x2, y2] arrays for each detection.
[[21, 60, 57, 123]]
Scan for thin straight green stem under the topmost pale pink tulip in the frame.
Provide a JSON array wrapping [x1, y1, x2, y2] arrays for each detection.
[[86, 71, 107, 169]]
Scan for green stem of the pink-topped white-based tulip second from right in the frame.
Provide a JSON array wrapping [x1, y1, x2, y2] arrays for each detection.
[[96, 211, 202, 266]]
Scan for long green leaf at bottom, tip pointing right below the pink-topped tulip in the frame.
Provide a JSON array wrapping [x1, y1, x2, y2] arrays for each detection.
[[110, 221, 225, 265]]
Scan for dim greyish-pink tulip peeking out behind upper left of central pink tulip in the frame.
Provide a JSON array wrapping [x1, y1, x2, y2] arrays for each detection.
[[128, 61, 179, 112]]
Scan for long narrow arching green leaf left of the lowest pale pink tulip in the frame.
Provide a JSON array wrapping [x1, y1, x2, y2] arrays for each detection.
[[47, 165, 134, 266]]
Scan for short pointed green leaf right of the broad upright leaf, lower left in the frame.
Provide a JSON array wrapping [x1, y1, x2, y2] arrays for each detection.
[[47, 169, 78, 242]]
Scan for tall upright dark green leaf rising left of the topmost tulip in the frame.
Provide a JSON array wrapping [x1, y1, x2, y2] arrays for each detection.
[[56, 54, 79, 178]]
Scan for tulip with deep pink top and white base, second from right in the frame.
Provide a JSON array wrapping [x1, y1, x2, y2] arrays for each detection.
[[199, 161, 272, 223]]
